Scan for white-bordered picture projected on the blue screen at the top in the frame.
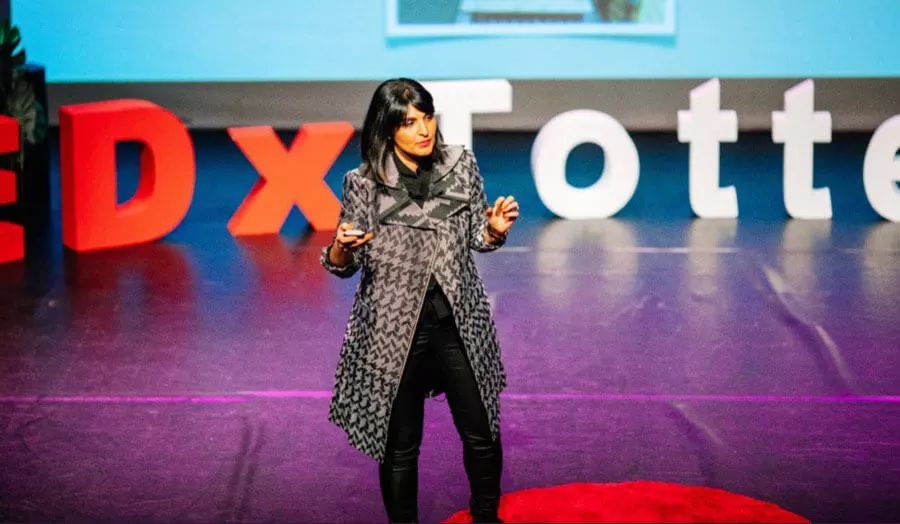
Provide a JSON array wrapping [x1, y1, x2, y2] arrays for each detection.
[[386, 0, 675, 37]]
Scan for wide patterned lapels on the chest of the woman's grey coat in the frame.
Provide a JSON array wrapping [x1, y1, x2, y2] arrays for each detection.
[[376, 146, 469, 229]]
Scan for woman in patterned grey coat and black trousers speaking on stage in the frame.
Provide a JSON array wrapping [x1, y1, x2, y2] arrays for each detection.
[[320, 78, 519, 522]]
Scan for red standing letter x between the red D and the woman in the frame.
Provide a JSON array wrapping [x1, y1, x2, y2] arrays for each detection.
[[228, 122, 353, 236]]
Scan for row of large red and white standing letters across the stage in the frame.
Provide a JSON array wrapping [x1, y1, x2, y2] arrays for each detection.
[[0, 80, 900, 262]]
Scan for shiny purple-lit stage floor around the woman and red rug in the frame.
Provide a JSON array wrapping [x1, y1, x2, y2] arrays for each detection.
[[0, 135, 900, 522]]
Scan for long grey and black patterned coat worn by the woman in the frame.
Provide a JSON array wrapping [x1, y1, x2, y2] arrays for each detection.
[[320, 146, 506, 462]]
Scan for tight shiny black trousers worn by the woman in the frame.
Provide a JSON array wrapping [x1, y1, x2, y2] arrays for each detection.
[[378, 301, 503, 522]]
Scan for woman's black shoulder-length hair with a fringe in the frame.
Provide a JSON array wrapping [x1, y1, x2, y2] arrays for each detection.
[[361, 78, 444, 182]]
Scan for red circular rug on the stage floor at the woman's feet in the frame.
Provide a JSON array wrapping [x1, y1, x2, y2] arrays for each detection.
[[444, 481, 809, 522]]
